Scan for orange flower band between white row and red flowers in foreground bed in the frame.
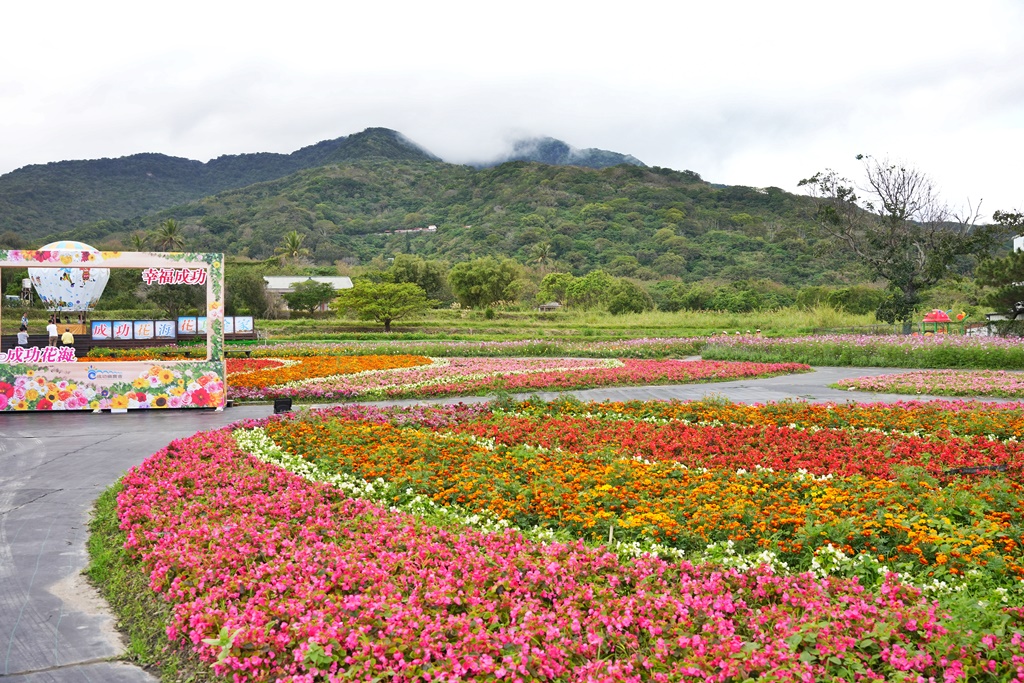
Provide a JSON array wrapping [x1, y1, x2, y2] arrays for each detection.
[[265, 404, 1024, 578]]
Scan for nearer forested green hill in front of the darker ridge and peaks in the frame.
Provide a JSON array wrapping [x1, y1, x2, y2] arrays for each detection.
[[67, 159, 863, 285]]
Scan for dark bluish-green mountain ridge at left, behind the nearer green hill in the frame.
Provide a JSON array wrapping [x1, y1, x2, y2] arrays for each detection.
[[0, 128, 437, 242]]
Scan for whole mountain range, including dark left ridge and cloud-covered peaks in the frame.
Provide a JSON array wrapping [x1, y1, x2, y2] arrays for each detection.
[[0, 128, 864, 285]]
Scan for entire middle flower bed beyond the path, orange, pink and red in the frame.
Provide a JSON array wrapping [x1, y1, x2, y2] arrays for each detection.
[[227, 355, 809, 401]]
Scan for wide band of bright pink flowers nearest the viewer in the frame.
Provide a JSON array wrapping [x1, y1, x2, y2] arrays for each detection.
[[118, 423, 1024, 683]]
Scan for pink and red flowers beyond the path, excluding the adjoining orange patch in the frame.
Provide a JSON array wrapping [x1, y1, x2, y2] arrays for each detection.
[[230, 358, 810, 400]]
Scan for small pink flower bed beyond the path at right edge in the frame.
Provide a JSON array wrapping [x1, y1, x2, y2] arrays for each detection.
[[837, 370, 1024, 398]]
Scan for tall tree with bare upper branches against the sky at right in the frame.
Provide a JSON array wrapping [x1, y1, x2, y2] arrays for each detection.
[[800, 156, 1006, 323]]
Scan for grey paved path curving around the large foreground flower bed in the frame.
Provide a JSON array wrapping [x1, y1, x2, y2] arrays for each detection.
[[0, 368, 1007, 683]]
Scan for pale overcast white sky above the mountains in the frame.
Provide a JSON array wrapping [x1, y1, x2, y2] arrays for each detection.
[[0, 0, 1024, 219]]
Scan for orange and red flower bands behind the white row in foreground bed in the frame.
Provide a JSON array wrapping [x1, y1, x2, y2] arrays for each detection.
[[266, 409, 1024, 582]]
